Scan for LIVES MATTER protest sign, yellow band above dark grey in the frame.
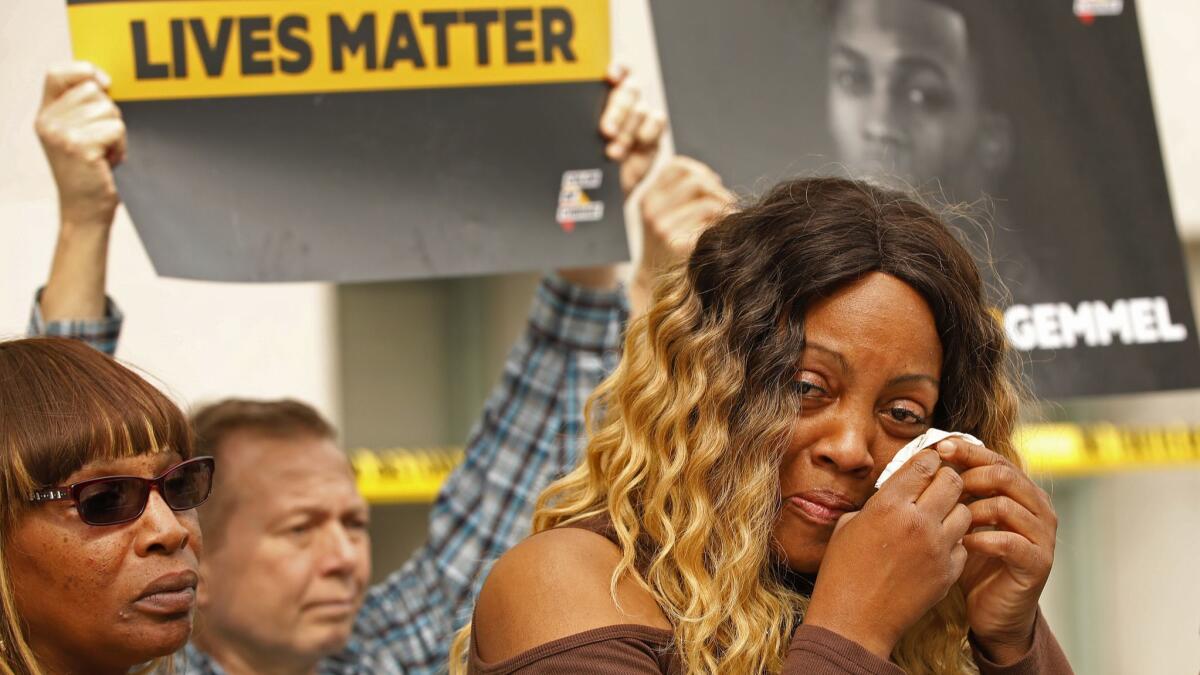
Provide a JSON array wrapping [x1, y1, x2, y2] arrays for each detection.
[[68, 0, 628, 281]]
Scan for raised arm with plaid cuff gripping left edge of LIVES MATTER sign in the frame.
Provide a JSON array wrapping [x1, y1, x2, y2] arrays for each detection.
[[29, 62, 125, 353]]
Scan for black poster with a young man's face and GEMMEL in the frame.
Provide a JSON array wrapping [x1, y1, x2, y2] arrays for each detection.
[[652, 0, 1200, 399]]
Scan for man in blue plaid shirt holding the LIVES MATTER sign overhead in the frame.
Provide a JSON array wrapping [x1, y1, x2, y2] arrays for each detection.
[[31, 60, 731, 675]]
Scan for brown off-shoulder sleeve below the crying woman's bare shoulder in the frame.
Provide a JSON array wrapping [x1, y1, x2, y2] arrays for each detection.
[[467, 626, 672, 675]]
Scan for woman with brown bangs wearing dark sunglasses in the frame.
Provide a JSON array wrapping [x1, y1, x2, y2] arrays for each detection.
[[0, 338, 212, 675]]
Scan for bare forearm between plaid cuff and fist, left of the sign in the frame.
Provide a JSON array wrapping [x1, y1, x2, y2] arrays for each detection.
[[42, 214, 110, 322]]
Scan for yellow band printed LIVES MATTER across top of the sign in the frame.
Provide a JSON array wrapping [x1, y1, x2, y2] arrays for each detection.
[[67, 0, 610, 101]]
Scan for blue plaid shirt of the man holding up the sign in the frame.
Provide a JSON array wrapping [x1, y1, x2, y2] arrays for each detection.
[[34, 276, 629, 675]]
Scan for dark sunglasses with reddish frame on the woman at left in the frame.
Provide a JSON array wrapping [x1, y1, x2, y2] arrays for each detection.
[[29, 458, 214, 525]]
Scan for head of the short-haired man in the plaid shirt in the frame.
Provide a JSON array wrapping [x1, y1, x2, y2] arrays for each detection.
[[182, 399, 371, 673]]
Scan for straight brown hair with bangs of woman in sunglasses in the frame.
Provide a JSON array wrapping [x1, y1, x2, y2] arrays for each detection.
[[0, 338, 193, 674]]
